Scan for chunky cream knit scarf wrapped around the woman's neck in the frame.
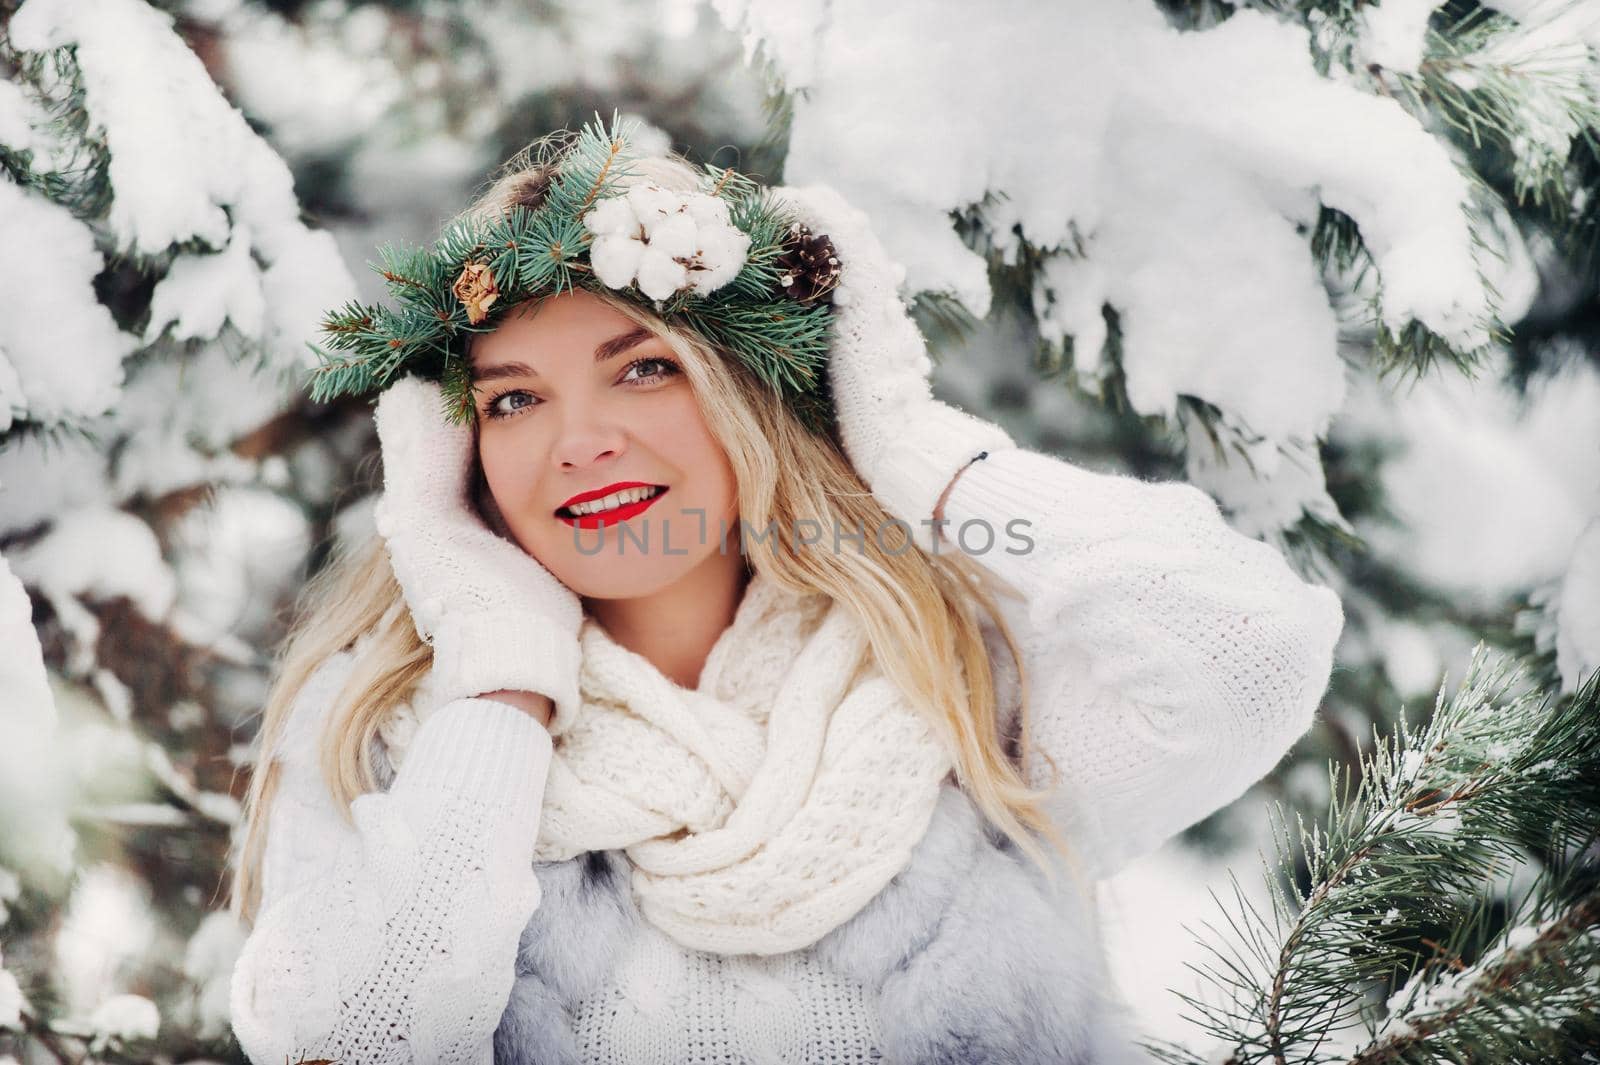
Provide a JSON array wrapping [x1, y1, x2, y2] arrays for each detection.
[[384, 572, 952, 955]]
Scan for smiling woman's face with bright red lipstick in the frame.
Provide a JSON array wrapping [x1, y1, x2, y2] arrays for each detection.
[[472, 289, 739, 598]]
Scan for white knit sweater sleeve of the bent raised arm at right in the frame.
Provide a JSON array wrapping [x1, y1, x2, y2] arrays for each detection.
[[930, 448, 1344, 876]]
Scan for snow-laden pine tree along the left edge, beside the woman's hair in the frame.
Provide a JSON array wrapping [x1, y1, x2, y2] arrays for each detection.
[[0, 0, 354, 1042]]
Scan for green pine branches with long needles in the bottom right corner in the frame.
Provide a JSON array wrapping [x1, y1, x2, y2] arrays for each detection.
[[1154, 644, 1600, 1065]]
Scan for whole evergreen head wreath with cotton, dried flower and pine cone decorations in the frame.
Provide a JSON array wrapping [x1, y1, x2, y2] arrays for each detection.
[[309, 112, 840, 433]]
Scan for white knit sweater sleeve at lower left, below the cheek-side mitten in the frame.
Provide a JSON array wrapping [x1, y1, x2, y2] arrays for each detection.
[[232, 652, 552, 1065]]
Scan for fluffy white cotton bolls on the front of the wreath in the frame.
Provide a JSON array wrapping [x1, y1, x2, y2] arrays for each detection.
[[582, 184, 750, 301]]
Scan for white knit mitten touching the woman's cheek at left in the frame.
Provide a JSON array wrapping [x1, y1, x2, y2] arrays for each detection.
[[373, 377, 582, 736]]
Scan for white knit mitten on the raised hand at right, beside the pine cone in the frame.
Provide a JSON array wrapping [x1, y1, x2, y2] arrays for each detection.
[[771, 184, 1014, 550]]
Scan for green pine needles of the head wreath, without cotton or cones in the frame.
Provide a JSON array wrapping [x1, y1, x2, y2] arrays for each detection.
[[309, 101, 832, 433]]
